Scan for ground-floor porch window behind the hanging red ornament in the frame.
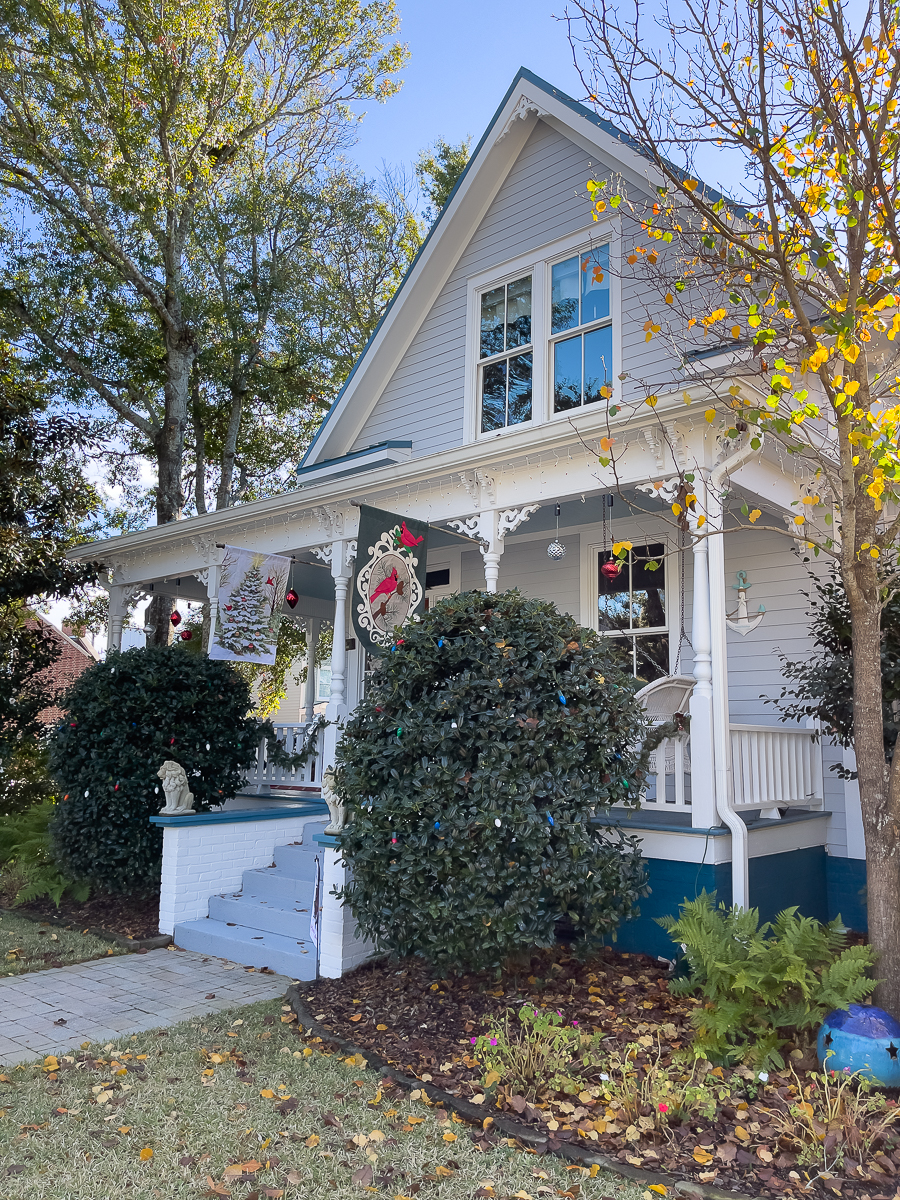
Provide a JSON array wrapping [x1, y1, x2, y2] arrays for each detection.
[[598, 542, 668, 683]]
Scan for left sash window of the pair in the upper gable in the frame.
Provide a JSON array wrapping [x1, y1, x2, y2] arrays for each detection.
[[479, 275, 534, 433]]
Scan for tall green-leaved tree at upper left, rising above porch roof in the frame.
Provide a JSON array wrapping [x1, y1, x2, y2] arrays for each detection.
[[0, 0, 404, 637]]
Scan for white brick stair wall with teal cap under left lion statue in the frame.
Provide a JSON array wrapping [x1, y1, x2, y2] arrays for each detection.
[[151, 811, 324, 934]]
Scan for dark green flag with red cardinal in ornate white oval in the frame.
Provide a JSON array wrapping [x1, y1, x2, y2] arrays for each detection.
[[352, 504, 428, 655]]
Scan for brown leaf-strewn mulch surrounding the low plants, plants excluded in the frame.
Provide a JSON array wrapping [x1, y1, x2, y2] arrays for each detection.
[[307, 947, 900, 1200]]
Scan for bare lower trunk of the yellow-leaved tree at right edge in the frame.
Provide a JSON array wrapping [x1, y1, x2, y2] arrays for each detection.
[[842, 552, 900, 1016]]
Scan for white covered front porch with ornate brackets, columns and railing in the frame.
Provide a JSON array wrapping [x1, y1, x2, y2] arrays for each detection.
[[75, 415, 846, 977]]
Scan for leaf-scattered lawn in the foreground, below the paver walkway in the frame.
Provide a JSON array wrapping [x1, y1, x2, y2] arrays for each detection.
[[0, 1001, 644, 1200]]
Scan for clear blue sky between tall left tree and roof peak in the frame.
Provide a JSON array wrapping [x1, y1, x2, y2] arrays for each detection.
[[349, 0, 584, 182]]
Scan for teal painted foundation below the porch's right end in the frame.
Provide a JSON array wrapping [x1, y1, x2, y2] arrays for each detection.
[[614, 846, 830, 959]]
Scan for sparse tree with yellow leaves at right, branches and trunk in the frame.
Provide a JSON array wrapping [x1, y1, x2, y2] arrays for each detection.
[[570, 0, 900, 1012]]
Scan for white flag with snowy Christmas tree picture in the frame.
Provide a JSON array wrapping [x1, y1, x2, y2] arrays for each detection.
[[209, 546, 290, 666]]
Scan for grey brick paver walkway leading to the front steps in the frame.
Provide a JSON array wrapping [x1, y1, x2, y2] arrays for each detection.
[[0, 950, 290, 1066]]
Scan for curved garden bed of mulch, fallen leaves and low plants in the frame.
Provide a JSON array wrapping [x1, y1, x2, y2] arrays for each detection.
[[304, 948, 900, 1200]]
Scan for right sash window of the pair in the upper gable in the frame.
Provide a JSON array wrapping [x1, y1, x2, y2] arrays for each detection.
[[550, 245, 612, 413]]
